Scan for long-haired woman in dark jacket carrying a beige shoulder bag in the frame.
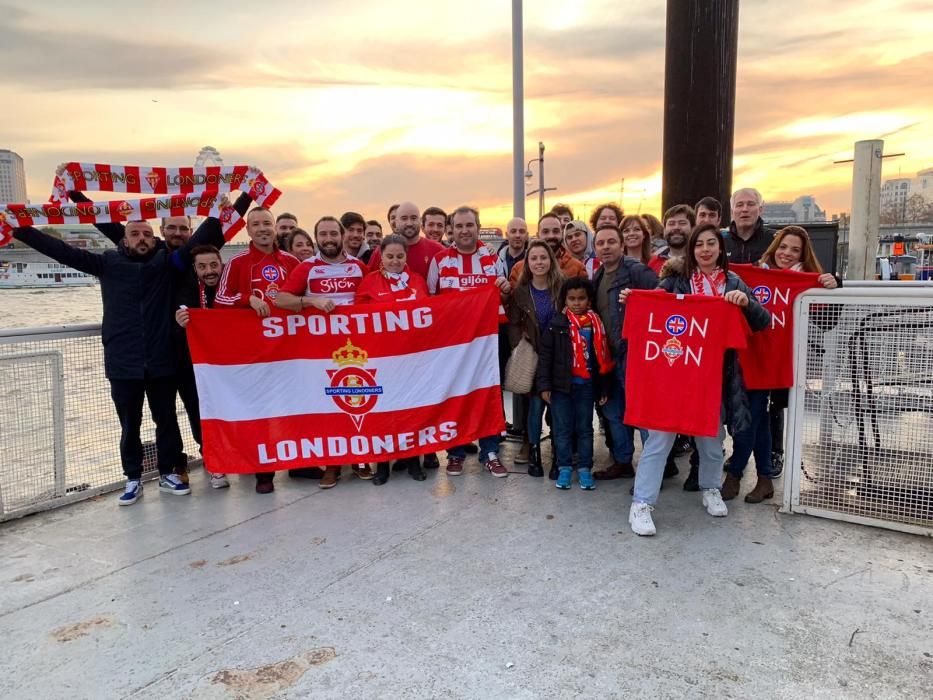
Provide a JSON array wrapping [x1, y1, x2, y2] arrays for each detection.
[[508, 240, 564, 477]]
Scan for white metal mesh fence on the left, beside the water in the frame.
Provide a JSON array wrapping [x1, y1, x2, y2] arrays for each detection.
[[0, 325, 198, 520]]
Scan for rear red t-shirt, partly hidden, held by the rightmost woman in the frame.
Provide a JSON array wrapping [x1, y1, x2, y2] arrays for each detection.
[[729, 265, 822, 389]]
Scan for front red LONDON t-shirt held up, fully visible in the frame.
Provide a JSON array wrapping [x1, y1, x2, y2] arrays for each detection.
[[622, 290, 751, 437]]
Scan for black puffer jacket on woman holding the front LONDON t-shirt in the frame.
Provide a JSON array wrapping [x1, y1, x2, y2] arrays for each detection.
[[658, 257, 771, 435]]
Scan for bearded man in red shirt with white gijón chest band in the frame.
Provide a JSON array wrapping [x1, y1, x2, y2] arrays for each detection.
[[275, 216, 374, 489]]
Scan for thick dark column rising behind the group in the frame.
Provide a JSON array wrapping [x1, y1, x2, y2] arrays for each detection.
[[661, 0, 739, 224]]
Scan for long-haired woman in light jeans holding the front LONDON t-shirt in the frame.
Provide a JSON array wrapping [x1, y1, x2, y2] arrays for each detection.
[[619, 224, 771, 535]]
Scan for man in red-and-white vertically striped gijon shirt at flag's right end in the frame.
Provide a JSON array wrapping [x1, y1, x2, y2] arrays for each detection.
[[428, 205, 512, 477]]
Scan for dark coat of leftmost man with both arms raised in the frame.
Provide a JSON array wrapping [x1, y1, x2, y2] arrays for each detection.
[[13, 219, 223, 379]]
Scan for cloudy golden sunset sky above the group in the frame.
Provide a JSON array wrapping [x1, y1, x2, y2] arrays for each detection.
[[0, 0, 933, 235]]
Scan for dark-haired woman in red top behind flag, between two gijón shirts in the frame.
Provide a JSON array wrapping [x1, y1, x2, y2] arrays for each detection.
[[353, 233, 428, 486]]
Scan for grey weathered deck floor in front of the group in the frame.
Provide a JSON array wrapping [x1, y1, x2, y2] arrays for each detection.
[[0, 446, 933, 700]]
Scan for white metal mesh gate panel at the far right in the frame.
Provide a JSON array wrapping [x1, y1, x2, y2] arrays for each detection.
[[788, 289, 933, 534]]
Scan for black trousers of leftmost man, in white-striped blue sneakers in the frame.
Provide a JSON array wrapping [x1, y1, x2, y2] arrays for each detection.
[[110, 377, 184, 479]]
